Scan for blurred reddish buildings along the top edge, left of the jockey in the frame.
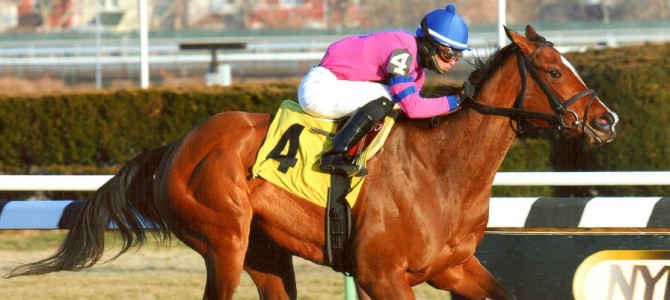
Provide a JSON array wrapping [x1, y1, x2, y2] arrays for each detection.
[[0, 0, 369, 33]]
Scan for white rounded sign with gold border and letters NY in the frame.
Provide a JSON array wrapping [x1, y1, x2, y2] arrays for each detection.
[[572, 250, 670, 300]]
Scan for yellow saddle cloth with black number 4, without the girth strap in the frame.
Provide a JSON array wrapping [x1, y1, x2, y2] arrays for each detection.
[[252, 100, 399, 207]]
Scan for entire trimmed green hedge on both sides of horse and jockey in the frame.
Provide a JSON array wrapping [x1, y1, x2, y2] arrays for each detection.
[[0, 45, 670, 196]]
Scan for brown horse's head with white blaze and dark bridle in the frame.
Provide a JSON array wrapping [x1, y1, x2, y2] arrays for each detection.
[[471, 25, 619, 146]]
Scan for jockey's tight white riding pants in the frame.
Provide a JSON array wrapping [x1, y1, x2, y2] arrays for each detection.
[[298, 66, 393, 119]]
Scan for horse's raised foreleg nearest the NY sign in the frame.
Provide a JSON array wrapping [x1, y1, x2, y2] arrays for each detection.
[[428, 256, 516, 300]]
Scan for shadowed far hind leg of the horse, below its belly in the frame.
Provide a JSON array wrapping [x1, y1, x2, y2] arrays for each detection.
[[244, 228, 297, 300]]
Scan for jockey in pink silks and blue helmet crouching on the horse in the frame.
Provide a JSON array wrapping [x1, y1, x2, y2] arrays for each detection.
[[298, 4, 472, 176]]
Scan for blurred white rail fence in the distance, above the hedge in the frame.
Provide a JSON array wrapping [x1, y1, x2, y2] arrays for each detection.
[[0, 27, 670, 69]]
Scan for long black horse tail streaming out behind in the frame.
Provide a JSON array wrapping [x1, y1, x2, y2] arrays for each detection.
[[6, 146, 170, 278]]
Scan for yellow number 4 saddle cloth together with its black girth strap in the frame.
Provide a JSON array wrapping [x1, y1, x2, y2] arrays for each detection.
[[251, 100, 400, 273]]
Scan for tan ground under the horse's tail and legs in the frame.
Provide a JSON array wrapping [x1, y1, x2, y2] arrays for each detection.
[[0, 244, 448, 300]]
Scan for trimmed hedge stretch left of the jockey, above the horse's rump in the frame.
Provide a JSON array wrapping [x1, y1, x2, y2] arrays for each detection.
[[0, 83, 295, 174]]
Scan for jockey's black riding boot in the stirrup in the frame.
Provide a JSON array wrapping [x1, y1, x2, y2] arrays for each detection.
[[321, 97, 393, 177]]
